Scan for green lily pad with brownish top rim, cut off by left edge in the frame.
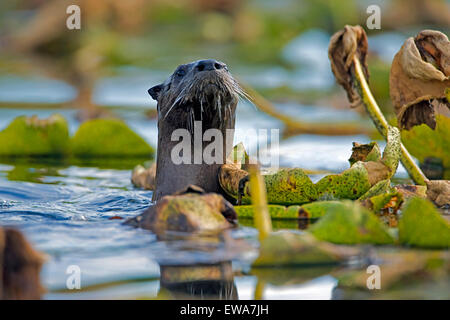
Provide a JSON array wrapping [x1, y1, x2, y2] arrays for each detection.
[[0, 114, 69, 157]]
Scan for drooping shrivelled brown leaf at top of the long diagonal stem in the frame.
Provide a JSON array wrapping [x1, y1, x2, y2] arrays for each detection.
[[328, 25, 369, 107]]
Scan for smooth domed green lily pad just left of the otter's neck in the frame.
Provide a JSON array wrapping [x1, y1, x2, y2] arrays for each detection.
[[72, 119, 154, 158]]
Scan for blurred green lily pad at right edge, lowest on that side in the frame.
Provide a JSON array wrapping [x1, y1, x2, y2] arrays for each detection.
[[398, 197, 450, 248]]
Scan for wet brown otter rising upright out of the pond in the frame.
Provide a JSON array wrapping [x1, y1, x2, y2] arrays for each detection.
[[148, 59, 245, 201]]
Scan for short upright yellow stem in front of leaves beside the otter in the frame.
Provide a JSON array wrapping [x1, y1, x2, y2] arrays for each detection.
[[249, 165, 272, 241]]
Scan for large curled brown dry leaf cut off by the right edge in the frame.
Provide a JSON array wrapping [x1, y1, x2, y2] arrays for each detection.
[[389, 30, 450, 130]]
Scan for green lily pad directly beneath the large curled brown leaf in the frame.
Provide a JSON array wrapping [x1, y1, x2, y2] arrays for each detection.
[[402, 114, 450, 179]]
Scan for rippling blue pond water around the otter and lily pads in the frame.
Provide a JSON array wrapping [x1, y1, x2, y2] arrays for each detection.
[[0, 73, 444, 299]]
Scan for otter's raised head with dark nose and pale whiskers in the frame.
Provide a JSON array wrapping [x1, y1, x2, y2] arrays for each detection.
[[148, 59, 244, 133]]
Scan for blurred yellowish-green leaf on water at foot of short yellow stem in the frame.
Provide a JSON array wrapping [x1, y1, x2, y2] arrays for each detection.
[[252, 231, 356, 268]]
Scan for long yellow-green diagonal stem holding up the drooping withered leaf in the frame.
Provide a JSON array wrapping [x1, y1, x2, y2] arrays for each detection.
[[353, 56, 428, 185]]
